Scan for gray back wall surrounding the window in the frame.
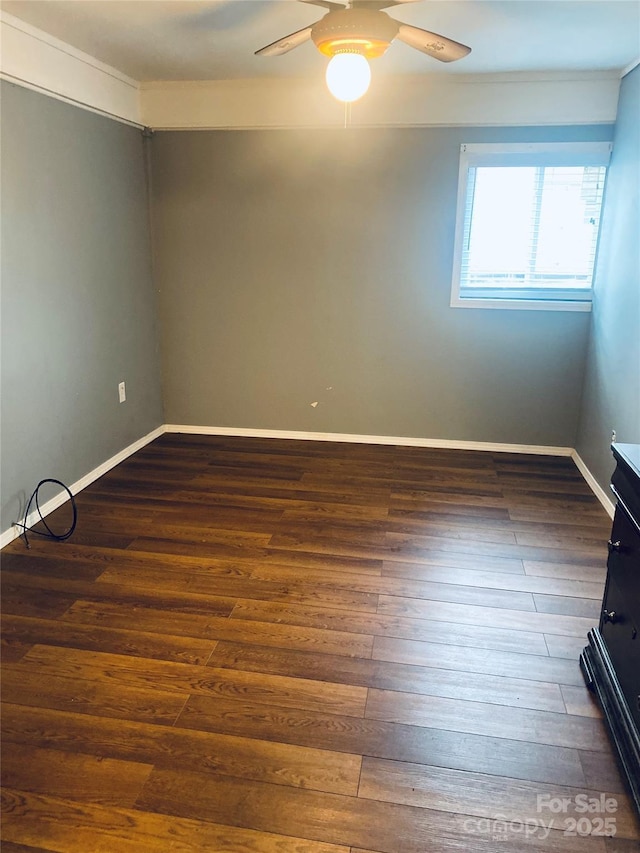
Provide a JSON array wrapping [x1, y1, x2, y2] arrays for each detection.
[[152, 126, 613, 446]]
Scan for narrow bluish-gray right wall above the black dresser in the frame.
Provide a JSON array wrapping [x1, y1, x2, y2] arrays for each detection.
[[576, 67, 640, 489]]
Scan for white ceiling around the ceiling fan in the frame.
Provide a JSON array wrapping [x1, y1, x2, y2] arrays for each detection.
[[0, 0, 640, 81]]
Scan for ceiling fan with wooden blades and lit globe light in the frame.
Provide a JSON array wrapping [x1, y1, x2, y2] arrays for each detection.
[[256, 0, 471, 102]]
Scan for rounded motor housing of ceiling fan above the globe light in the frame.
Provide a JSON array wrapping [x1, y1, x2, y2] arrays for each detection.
[[311, 8, 400, 59]]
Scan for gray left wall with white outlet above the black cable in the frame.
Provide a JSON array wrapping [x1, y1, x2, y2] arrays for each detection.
[[1, 83, 163, 531]]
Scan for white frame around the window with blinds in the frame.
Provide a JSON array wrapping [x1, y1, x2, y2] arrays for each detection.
[[451, 142, 612, 311]]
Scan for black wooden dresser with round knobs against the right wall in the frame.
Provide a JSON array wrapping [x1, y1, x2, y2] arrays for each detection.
[[580, 444, 640, 812]]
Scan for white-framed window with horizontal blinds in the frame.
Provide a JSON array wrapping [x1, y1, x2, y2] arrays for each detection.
[[451, 142, 611, 311]]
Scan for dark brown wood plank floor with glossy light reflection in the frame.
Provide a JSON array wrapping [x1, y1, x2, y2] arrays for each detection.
[[2, 435, 640, 853]]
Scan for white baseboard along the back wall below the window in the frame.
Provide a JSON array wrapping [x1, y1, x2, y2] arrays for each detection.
[[165, 424, 574, 456]]
